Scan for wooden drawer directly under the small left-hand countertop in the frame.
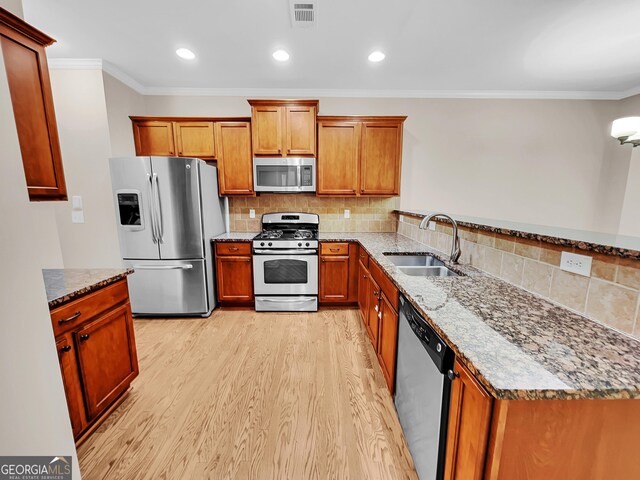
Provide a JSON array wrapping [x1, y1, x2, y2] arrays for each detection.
[[51, 280, 129, 336]]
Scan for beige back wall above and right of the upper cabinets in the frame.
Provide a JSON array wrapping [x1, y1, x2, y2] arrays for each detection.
[[146, 96, 629, 233]]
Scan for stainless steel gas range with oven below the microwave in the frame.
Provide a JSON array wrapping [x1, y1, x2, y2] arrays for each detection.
[[253, 213, 320, 312]]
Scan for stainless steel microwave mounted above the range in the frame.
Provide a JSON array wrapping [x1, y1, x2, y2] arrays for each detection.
[[253, 157, 316, 193]]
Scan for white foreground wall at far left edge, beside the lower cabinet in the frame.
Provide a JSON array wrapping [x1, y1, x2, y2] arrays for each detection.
[[0, 18, 80, 479]]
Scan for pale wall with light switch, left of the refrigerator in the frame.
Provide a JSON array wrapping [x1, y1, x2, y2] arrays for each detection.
[[51, 70, 122, 268]]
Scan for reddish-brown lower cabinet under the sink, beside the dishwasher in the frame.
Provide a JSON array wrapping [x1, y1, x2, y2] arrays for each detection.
[[358, 252, 399, 393]]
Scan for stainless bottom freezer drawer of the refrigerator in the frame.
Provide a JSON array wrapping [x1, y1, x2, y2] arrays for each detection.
[[124, 259, 211, 315]]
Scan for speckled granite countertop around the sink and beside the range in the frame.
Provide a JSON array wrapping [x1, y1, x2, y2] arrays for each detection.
[[215, 233, 640, 399]]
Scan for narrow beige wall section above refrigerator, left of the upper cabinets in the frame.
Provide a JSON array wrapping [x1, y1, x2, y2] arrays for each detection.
[[103, 73, 146, 157]]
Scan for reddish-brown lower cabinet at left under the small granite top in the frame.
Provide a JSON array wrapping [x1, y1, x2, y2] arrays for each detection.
[[51, 280, 138, 441]]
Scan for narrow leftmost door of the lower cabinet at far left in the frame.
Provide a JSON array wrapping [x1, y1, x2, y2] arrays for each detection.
[[56, 333, 87, 438]]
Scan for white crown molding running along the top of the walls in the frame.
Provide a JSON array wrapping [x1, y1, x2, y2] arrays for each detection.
[[48, 58, 640, 100]]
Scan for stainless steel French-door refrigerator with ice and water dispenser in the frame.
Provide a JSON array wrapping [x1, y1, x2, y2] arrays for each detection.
[[109, 157, 225, 316]]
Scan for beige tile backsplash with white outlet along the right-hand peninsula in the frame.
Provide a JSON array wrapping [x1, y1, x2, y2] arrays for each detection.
[[398, 216, 640, 338]]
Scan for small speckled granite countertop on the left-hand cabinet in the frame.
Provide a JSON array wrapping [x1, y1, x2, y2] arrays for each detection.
[[42, 268, 133, 309]]
